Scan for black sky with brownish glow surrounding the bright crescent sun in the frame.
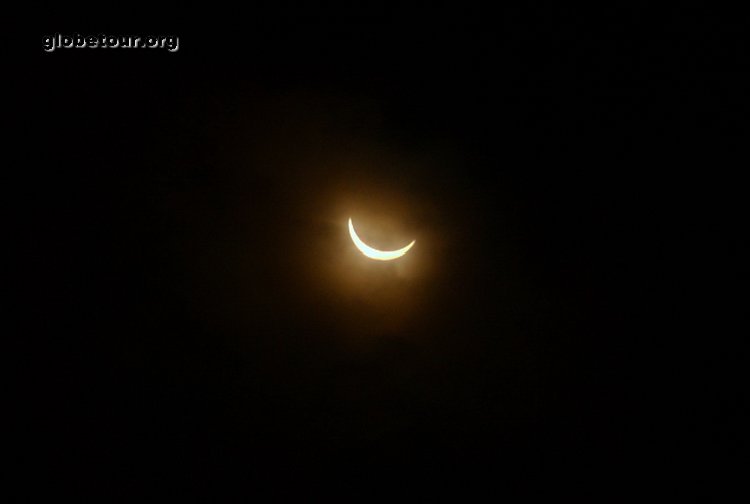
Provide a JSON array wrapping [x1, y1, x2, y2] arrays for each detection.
[[17, 6, 747, 502]]
